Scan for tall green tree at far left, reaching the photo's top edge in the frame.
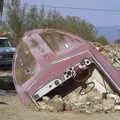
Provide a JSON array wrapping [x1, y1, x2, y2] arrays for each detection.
[[6, 0, 26, 45]]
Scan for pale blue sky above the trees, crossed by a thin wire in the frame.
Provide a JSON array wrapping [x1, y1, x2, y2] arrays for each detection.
[[21, 0, 120, 26]]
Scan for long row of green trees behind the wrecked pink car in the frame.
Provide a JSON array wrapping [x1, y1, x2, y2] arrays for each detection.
[[6, 0, 97, 45]]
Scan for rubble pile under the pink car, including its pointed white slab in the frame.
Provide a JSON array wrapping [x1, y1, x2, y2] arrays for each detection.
[[35, 70, 120, 114]]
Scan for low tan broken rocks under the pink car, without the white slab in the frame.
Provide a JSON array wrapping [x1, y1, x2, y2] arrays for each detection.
[[38, 89, 120, 114]]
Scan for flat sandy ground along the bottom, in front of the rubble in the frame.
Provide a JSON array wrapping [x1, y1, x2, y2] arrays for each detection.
[[0, 93, 120, 120]]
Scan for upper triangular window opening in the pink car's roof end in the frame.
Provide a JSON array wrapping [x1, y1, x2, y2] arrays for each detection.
[[41, 31, 80, 55]]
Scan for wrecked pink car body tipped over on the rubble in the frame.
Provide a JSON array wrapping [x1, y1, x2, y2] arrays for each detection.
[[13, 29, 120, 104]]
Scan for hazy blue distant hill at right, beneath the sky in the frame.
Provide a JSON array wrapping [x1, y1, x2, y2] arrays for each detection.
[[96, 26, 120, 43]]
